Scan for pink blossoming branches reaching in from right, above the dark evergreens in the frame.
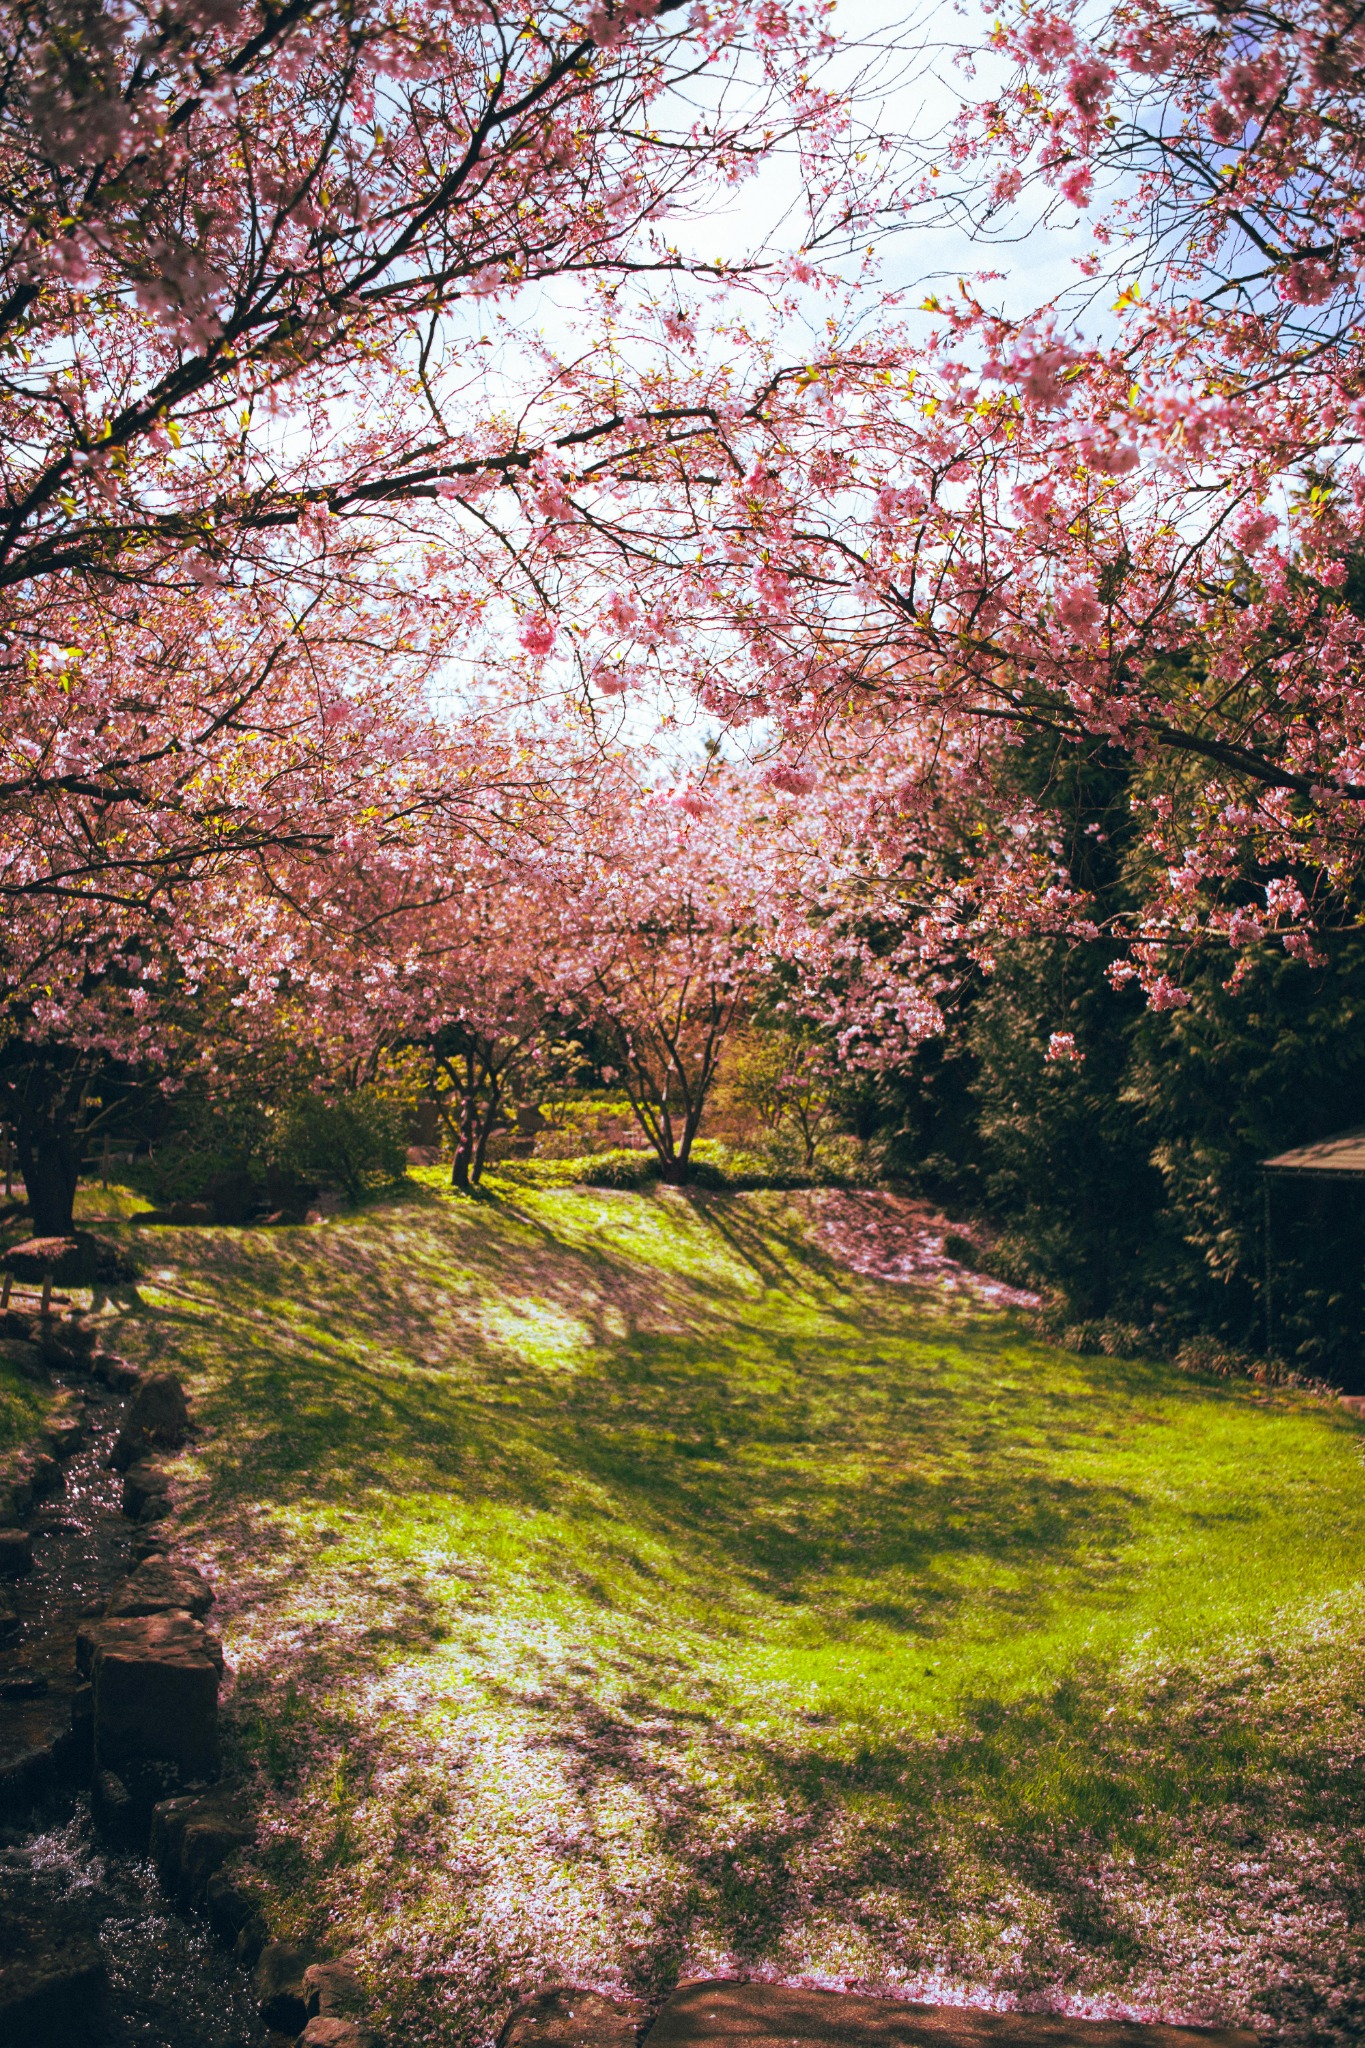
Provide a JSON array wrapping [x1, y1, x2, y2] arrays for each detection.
[[491, 4, 1365, 1006]]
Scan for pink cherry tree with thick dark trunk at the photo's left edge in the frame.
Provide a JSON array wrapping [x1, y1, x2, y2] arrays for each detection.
[[0, 592, 540, 1235]]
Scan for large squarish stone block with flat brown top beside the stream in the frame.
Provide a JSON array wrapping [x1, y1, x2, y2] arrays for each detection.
[[76, 1614, 223, 1780]]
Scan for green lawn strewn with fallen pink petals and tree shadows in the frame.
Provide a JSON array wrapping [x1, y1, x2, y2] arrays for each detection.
[[90, 1176, 1365, 2044]]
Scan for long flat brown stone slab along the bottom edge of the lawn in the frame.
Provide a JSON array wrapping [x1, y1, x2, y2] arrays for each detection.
[[645, 1980, 1257, 2048]]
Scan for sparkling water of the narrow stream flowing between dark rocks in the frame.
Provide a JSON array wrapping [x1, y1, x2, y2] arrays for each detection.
[[0, 1343, 266, 2048]]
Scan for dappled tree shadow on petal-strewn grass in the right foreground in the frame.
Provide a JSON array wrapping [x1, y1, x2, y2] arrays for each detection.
[[472, 1655, 1365, 2005]]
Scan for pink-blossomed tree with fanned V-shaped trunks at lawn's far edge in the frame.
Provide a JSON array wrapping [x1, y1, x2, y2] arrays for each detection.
[[573, 770, 939, 1184]]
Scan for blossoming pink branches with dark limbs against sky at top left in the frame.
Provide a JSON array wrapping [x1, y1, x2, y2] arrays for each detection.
[[0, 0, 847, 745]]
